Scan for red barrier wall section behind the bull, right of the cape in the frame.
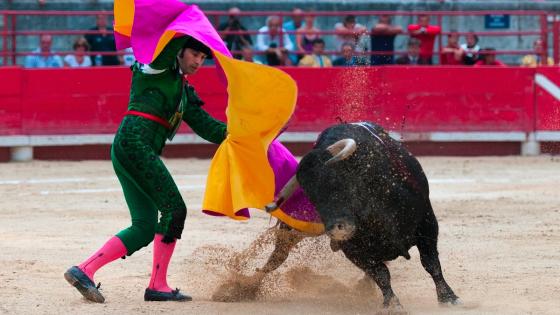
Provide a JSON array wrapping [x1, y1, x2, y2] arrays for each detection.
[[288, 67, 534, 132]]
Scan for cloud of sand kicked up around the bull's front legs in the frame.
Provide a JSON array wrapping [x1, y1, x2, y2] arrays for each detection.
[[201, 228, 377, 304]]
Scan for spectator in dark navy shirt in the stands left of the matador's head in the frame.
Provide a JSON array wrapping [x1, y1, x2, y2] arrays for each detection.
[[85, 14, 121, 66]]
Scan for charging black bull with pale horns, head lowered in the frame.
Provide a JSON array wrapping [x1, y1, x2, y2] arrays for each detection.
[[263, 123, 459, 307]]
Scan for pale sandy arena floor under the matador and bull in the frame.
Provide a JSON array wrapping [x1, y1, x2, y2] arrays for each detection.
[[0, 157, 560, 315]]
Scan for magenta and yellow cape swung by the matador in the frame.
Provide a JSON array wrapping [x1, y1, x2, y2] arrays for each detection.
[[114, 0, 323, 234]]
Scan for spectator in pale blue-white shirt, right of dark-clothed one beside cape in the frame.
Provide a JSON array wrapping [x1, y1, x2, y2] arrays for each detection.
[[256, 15, 294, 66]]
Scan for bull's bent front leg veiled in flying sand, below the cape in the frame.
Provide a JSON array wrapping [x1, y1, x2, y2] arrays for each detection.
[[257, 222, 306, 277]]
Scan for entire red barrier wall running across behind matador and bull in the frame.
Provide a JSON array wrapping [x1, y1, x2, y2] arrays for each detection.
[[0, 67, 560, 135]]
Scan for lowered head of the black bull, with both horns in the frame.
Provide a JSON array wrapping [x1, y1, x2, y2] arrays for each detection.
[[266, 139, 357, 241]]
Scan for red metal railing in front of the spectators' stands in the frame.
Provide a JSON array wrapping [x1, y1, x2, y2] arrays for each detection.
[[0, 10, 560, 66]]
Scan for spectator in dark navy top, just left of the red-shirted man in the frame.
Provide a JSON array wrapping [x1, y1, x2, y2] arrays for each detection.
[[371, 14, 402, 66]]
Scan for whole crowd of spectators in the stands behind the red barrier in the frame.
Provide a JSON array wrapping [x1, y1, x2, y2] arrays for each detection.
[[20, 7, 554, 68]]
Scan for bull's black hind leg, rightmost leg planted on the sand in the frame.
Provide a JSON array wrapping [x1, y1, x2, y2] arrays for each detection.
[[416, 209, 460, 304]]
